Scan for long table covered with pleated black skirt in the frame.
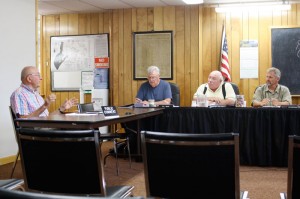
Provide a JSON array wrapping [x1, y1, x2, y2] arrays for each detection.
[[142, 107, 300, 167]]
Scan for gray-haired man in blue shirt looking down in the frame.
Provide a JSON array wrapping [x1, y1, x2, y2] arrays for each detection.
[[135, 66, 172, 106]]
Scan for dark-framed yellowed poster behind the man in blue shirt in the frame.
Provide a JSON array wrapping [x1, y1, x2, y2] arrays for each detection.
[[133, 31, 173, 80]]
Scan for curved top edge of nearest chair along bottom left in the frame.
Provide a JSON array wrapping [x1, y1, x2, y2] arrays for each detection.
[[0, 188, 144, 199]]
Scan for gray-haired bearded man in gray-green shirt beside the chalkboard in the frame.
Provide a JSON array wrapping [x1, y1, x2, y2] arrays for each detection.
[[252, 67, 292, 107]]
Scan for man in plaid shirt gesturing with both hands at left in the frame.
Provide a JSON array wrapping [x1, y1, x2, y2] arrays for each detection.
[[10, 66, 78, 118]]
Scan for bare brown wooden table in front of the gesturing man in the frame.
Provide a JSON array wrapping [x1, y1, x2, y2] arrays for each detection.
[[17, 107, 163, 159]]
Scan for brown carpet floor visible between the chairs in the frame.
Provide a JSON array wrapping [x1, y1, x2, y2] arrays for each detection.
[[0, 142, 287, 199]]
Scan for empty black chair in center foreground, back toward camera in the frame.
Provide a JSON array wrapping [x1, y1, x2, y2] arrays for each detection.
[[141, 131, 248, 199]]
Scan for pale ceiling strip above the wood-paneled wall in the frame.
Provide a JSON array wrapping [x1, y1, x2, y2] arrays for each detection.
[[38, 0, 292, 15]]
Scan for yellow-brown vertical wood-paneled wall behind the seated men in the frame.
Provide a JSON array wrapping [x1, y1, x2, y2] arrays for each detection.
[[41, 4, 300, 110]]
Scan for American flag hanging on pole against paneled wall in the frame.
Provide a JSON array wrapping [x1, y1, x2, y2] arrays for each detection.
[[220, 26, 231, 82]]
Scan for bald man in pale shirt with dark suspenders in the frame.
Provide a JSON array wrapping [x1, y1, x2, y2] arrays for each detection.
[[193, 70, 236, 106]]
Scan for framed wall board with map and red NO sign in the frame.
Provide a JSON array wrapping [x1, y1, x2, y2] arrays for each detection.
[[50, 34, 109, 91]]
